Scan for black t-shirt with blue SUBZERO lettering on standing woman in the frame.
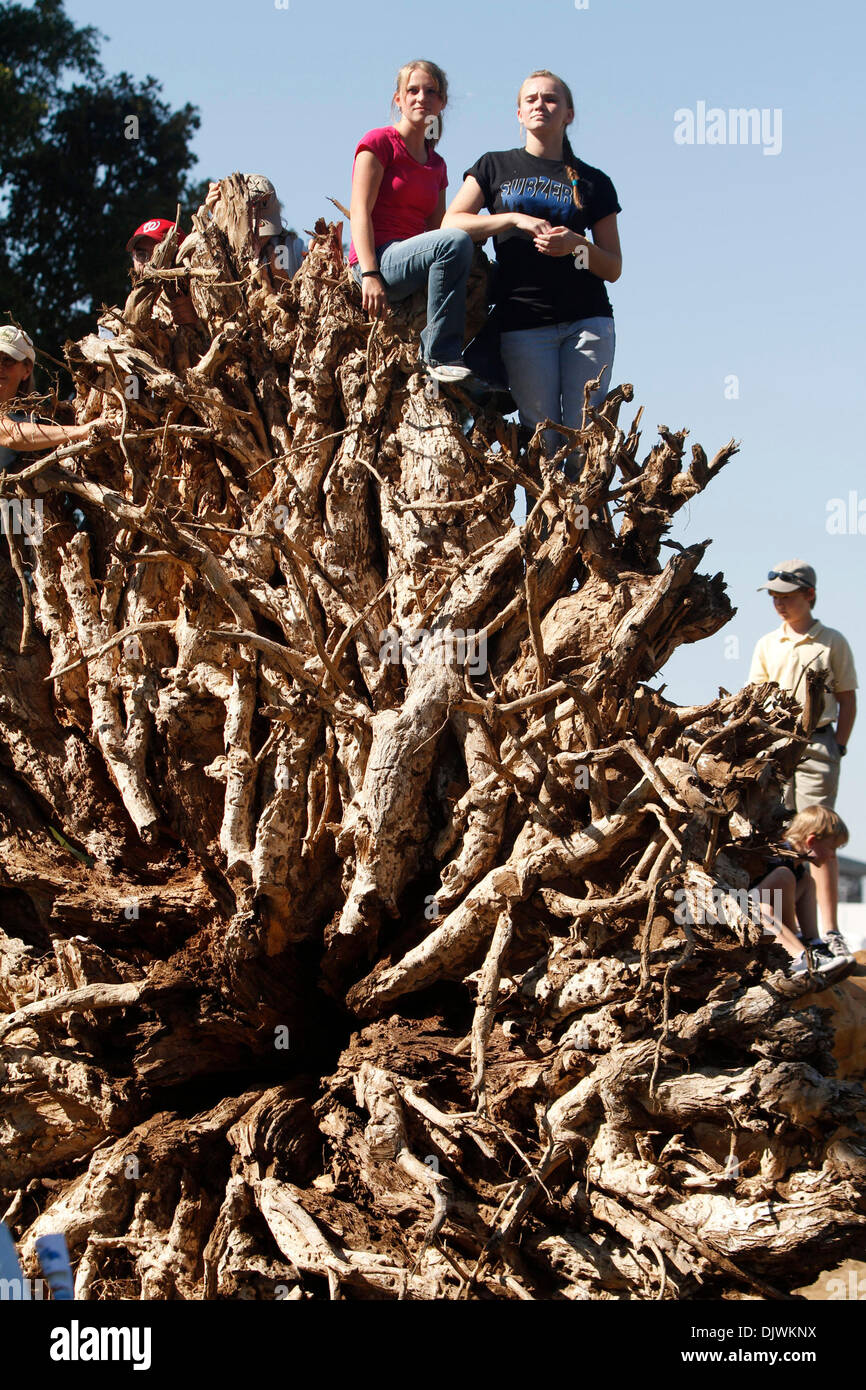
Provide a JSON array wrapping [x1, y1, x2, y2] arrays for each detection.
[[463, 149, 621, 331]]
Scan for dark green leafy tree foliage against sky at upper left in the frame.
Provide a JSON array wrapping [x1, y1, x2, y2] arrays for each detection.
[[0, 0, 202, 356]]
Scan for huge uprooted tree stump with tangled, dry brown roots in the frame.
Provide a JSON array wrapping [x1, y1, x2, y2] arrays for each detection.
[[0, 177, 866, 1298]]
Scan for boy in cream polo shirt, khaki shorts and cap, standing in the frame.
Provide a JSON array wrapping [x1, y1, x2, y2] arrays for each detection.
[[749, 560, 858, 955]]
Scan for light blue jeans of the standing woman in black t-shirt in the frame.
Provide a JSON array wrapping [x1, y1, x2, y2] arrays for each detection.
[[502, 317, 616, 467]]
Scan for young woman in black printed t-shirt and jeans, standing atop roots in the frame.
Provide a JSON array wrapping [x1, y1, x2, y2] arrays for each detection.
[[442, 70, 623, 469]]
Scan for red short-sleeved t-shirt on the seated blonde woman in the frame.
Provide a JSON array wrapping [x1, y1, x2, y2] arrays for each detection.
[[349, 125, 448, 265]]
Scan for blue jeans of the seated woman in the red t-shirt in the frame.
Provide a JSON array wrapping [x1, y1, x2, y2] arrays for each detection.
[[352, 228, 474, 366]]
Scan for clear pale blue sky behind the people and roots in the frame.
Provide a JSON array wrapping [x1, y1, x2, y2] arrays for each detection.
[[67, 0, 866, 859]]
